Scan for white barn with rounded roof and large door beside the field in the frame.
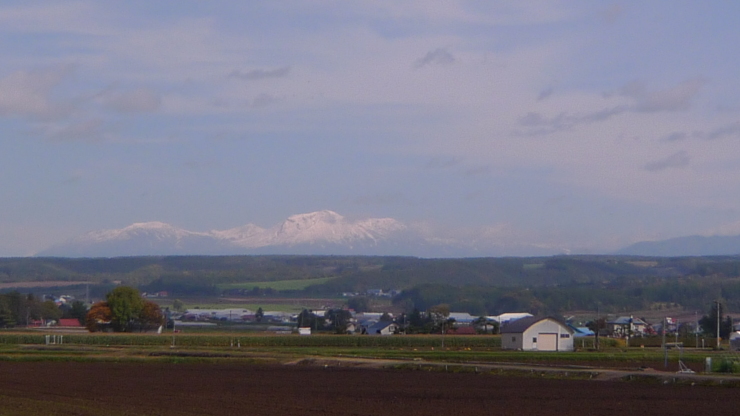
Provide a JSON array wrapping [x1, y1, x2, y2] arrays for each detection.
[[501, 317, 573, 351]]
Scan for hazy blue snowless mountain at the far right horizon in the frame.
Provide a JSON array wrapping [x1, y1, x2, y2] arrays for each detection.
[[616, 235, 740, 257]]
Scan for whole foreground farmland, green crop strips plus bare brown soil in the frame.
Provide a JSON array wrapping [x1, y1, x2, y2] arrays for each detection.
[[0, 331, 740, 415]]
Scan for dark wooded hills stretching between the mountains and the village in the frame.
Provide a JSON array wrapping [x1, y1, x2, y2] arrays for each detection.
[[0, 256, 740, 314]]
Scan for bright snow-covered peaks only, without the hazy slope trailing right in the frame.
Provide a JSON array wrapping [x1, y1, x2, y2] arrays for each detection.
[[38, 211, 406, 257]]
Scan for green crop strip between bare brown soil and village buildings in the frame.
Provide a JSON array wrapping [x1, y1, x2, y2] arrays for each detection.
[[0, 331, 740, 373]]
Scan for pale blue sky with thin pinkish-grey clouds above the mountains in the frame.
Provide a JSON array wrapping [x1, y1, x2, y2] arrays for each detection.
[[0, 0, 740, 256]]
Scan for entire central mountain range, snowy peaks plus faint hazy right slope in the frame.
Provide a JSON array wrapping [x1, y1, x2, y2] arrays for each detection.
[[37, 210, 567, 257]]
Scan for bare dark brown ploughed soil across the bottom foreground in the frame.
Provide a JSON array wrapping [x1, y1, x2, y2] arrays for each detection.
[[0, 362, 738, 416]]
